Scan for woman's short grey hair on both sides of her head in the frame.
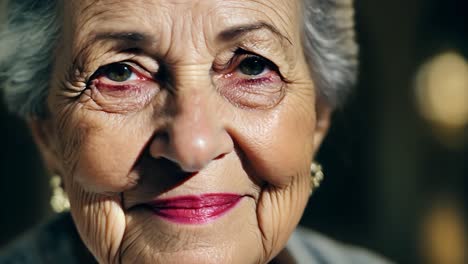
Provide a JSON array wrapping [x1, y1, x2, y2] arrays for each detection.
[[0, 0, 357, 117]]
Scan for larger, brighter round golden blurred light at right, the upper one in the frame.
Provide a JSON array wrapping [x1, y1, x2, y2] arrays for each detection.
[[416, 51, 468, 147]]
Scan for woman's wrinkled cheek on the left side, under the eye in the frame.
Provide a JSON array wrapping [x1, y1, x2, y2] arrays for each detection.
[[63, 114, 151, 193]]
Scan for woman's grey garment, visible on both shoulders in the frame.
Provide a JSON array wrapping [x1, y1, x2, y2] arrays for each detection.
[[0, 213, 390, 264]]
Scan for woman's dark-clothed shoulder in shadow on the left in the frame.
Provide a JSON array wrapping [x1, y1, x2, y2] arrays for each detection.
[[0, 214, 85, 264]]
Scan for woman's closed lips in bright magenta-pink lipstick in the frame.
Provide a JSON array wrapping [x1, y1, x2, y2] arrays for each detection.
[[148, 193, 243, 224]]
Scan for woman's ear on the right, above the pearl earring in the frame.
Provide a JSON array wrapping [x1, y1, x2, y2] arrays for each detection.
[[314, 97, 333, 155]]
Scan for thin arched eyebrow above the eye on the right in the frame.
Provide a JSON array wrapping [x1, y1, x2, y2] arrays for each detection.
[[218, 22, 292, 45]]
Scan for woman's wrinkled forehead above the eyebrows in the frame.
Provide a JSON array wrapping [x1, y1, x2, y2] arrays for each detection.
[[63, 0, 301, 46]]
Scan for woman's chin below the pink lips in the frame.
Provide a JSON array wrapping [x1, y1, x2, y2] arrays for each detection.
[[121, 199, 263, 264]]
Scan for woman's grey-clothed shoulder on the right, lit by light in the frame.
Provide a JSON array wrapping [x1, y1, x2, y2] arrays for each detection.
[[287, 227, 392, 264]]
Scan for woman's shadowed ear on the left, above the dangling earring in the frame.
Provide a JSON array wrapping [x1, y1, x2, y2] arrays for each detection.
[[27, 118, 61, 175]]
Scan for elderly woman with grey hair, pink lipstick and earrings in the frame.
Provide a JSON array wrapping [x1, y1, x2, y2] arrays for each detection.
[[0, 0, 384, 263]]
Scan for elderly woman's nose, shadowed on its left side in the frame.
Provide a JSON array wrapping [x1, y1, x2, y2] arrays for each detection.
[[150, 92, 234, 172]]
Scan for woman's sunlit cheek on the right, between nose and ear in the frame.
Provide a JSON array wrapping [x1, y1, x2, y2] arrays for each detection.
[[233, 94, 315, 187]]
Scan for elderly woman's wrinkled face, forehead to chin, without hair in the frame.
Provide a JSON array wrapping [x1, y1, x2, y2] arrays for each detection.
[[35, 0, 326, 263]]
